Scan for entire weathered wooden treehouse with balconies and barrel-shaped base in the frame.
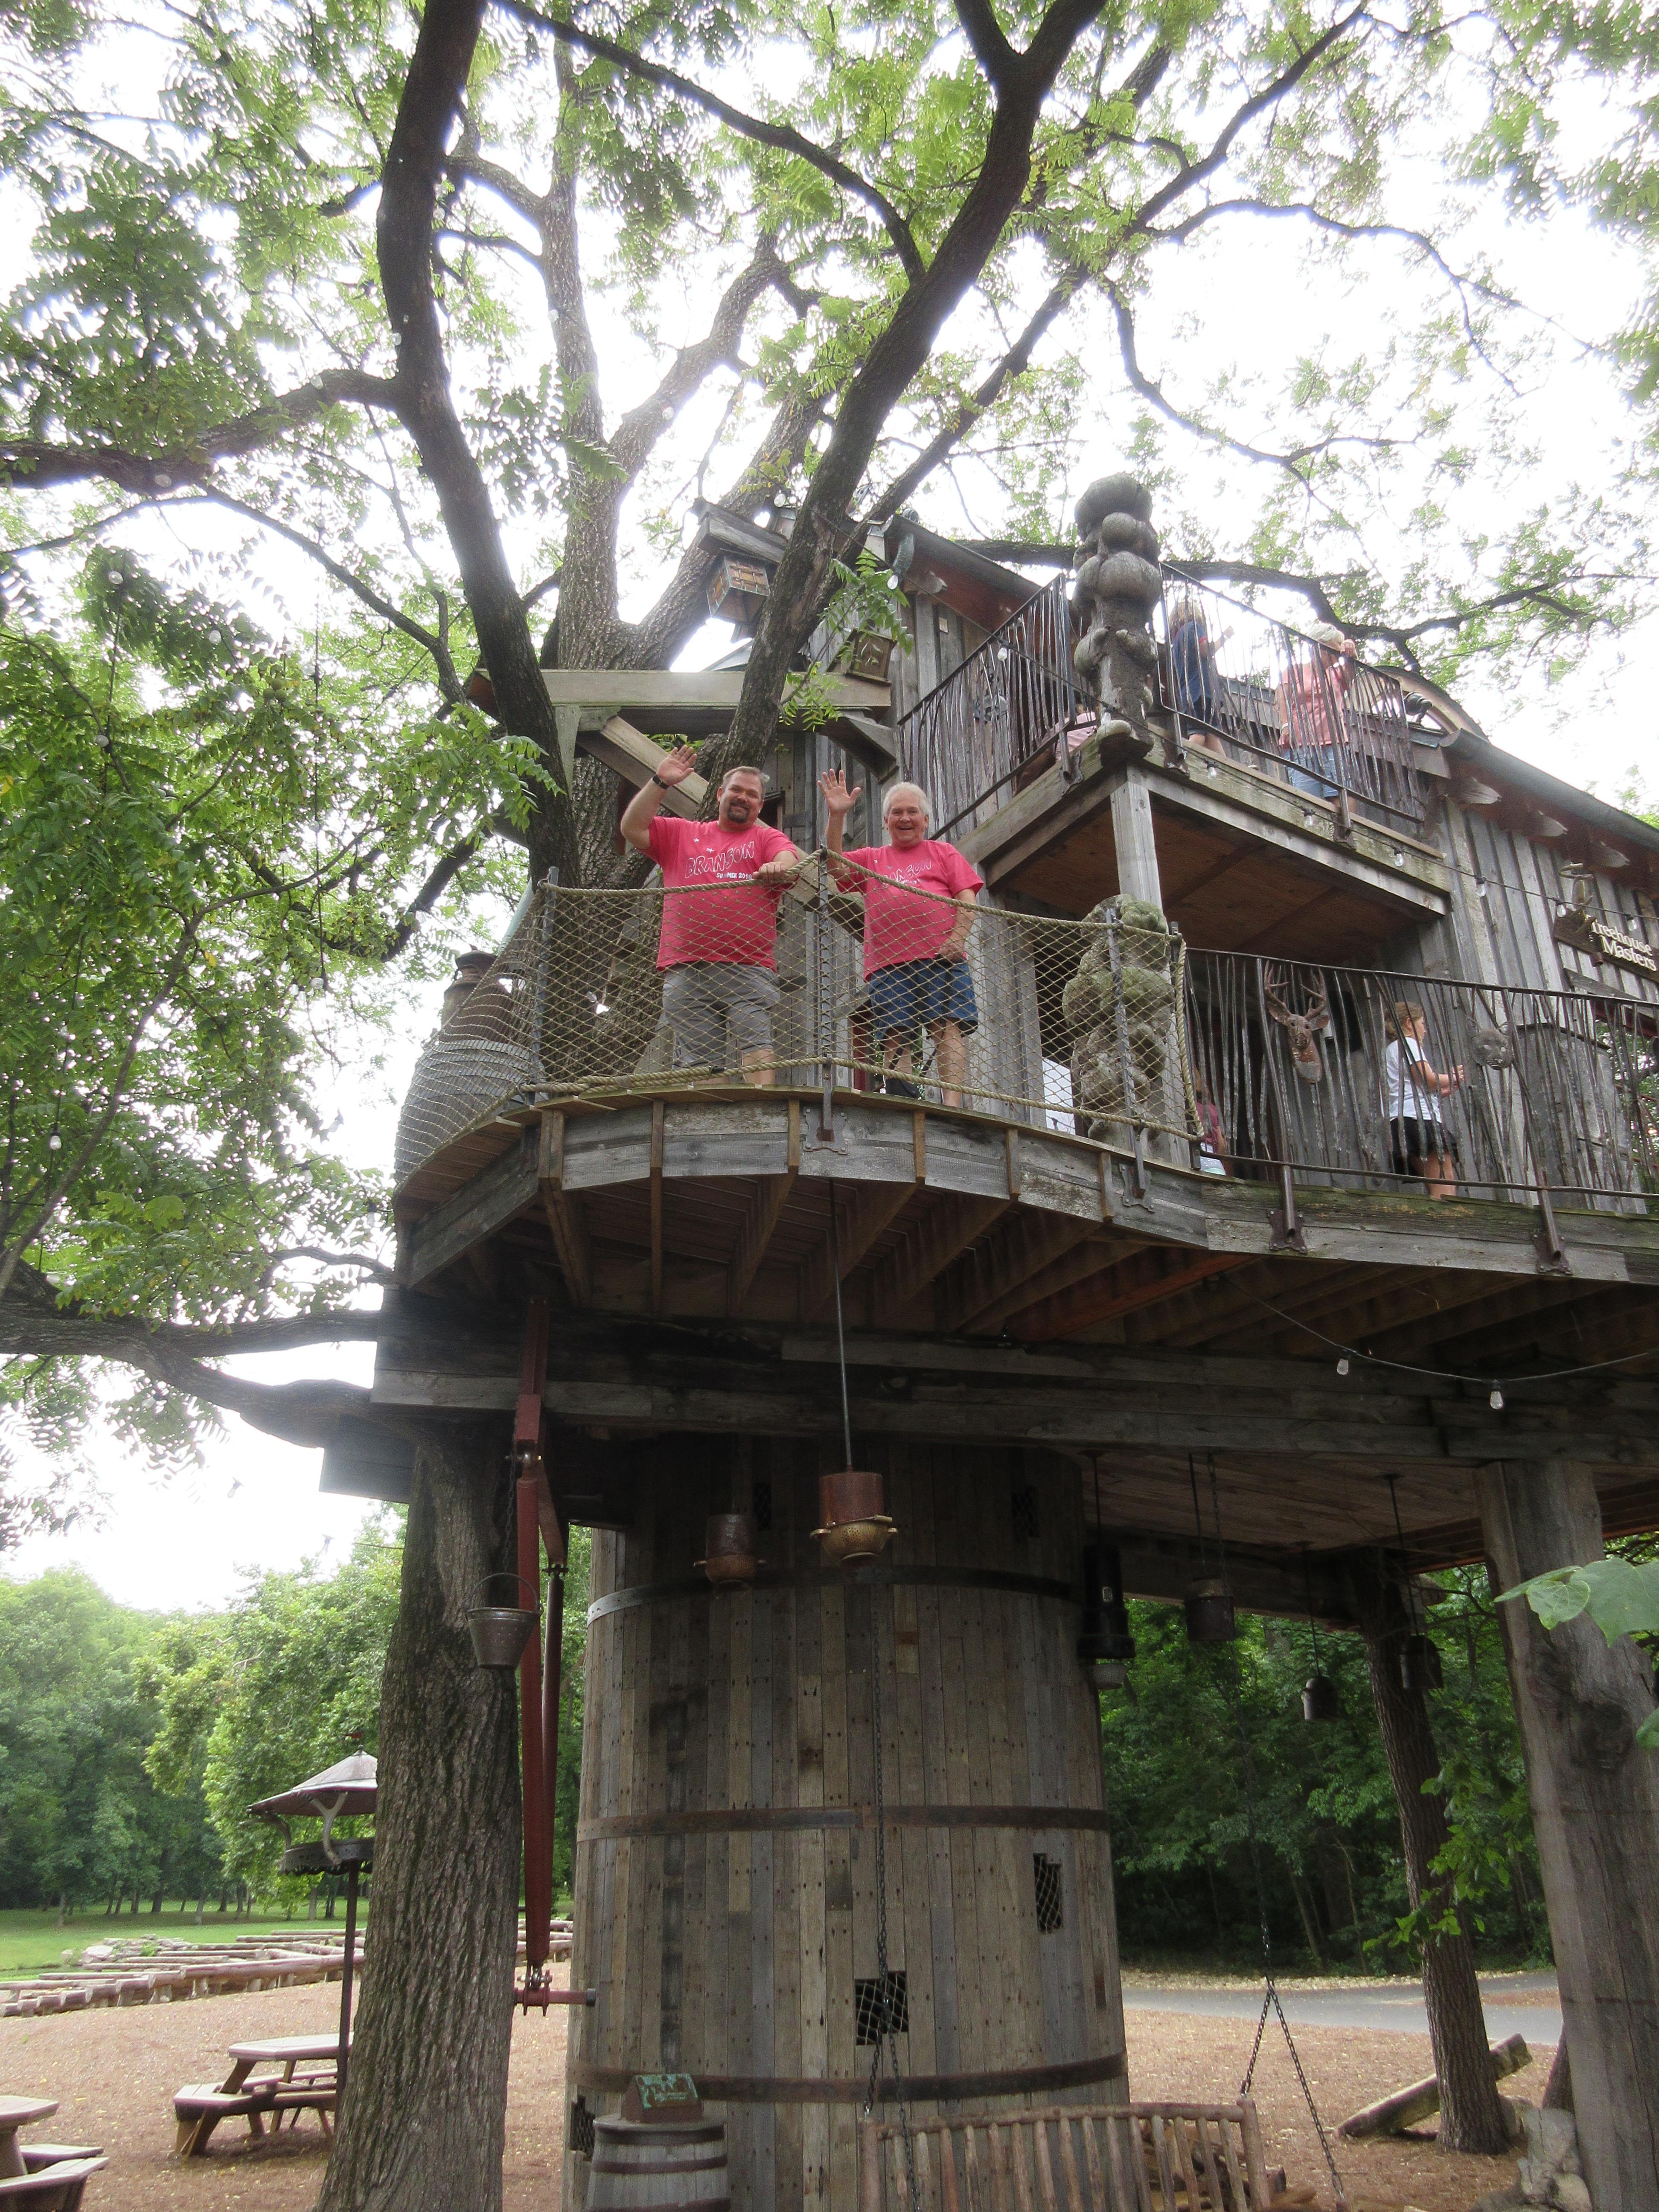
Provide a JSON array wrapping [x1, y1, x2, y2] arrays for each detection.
[[345, 478, 1659, 2212]]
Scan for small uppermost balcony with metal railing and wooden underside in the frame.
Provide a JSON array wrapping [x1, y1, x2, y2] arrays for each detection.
[[896, 568, 1449, 960]]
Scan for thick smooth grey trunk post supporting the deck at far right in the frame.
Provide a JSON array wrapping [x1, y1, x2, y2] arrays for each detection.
[[1480, 1460, 1659, 2212]]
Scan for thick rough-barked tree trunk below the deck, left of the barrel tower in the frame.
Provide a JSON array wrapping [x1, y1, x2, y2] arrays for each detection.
[[316, 1420, 520, 2212]]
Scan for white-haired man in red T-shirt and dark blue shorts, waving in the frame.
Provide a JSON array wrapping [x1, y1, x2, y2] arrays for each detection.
[[818, 768, 984, 1106]]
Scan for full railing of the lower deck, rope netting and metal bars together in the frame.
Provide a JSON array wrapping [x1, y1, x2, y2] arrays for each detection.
[[396, 854, 1659, 1210]]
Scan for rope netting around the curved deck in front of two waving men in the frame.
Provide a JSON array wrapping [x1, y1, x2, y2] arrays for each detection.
[[396, 852, 1203, 1181]]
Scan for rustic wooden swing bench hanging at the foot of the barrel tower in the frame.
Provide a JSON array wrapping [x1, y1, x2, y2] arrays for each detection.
[[858, 2097, 1272, 2212]]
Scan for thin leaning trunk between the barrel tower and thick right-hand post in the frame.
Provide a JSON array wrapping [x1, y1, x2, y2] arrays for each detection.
[[1360, 1575, 1513, 2150]]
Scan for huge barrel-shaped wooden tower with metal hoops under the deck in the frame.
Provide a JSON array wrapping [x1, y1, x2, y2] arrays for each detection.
[[564, 1435, 1126, 2212]]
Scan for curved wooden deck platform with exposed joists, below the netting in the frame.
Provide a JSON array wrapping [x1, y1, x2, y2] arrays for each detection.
[[398, 1091, 1659, 1369]]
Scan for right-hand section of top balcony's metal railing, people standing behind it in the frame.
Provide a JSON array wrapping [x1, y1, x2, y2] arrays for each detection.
[[1159, 566, 1422, 832]]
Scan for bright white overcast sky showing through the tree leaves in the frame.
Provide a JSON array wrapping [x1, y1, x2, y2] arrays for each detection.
[[0, 17, 1659, 1608]]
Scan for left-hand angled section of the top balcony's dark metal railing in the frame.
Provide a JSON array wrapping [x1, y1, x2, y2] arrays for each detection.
[[894, 577, 1095, 836]]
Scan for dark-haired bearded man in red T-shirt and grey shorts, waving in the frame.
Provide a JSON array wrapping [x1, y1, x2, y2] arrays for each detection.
[[622, 745, 805, 1086]]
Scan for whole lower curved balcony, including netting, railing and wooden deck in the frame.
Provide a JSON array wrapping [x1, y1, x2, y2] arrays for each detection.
[[398, 856, 1659, 1351]]
